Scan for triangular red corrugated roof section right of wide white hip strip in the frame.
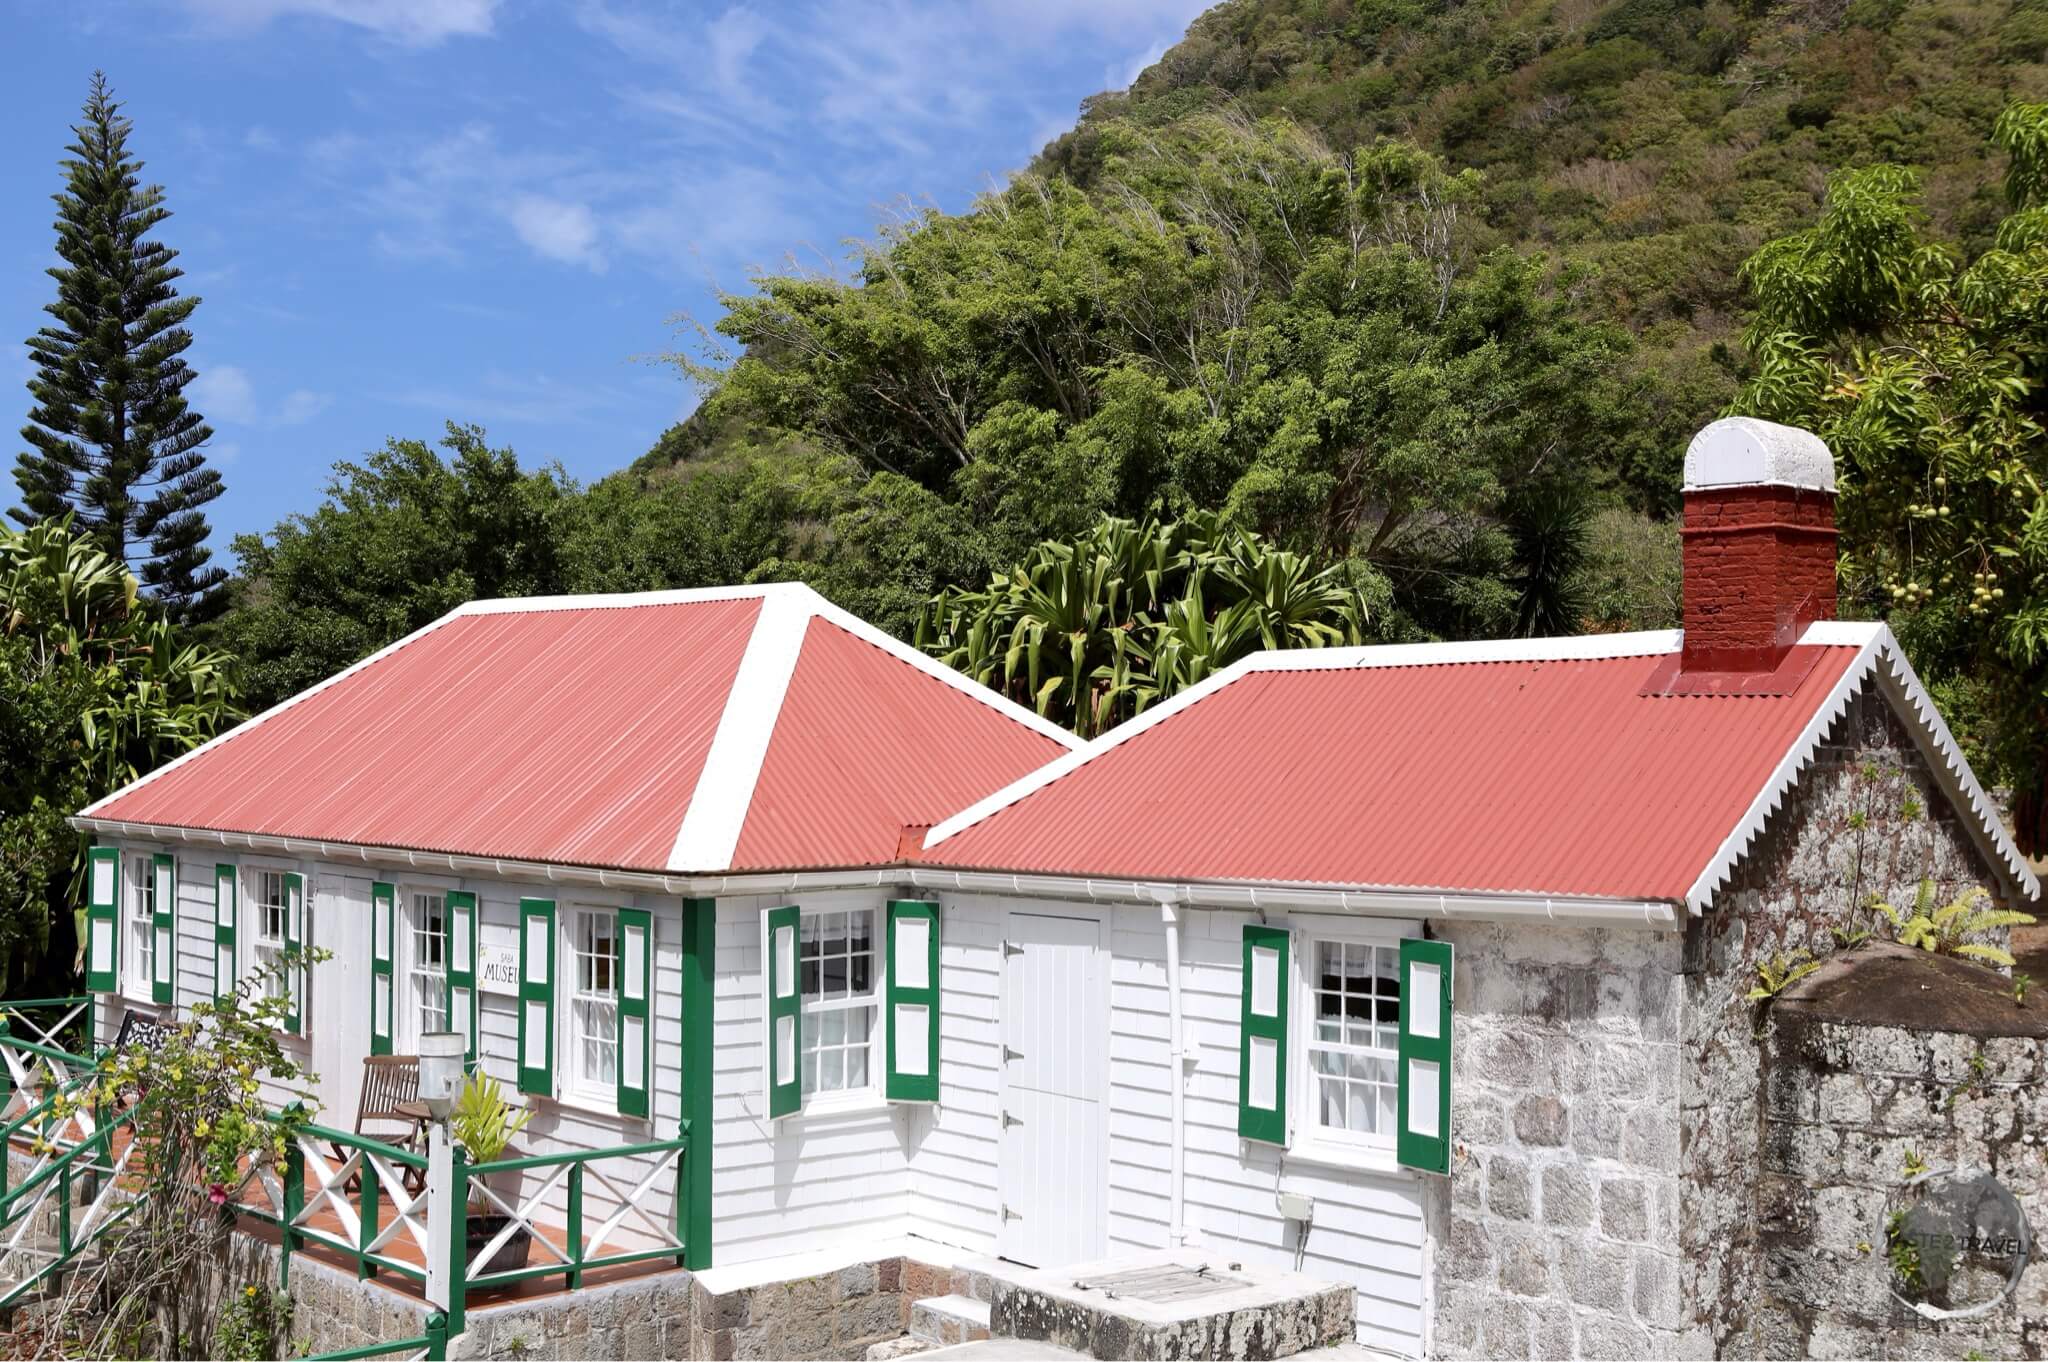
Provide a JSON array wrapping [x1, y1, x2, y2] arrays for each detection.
[[733, 616, 1067, 870]]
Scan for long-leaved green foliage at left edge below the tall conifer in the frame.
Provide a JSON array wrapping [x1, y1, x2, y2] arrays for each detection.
[[0, 520, 240, 991]]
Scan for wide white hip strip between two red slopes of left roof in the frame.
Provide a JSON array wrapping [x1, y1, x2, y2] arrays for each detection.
[[668, 592, 811, 870]]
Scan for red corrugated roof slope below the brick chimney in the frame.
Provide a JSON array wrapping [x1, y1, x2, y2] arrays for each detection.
[[926, 635, 1860, 899]]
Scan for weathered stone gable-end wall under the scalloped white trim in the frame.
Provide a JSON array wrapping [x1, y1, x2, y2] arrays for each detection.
[[1675, 690, 1999, 1356]]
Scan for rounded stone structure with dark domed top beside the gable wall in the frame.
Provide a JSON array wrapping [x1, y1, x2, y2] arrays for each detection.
[[1745, 948, 2048, 1358]]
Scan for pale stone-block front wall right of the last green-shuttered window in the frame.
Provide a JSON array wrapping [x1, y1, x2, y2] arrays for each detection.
[[1432, 922, 1679, 1358]]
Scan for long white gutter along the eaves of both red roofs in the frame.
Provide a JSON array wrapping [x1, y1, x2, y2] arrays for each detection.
[[68, 815, 1679, 930]]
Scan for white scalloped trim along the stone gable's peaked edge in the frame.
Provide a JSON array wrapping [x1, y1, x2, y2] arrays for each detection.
[[1686, 623, 2040, 913]]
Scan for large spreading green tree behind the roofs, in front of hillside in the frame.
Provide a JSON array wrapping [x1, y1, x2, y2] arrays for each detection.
[[680, 115, 1642, 635]]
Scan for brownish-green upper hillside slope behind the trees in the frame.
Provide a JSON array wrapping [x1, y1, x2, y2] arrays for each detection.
[[1038, 0, 2048, 508]]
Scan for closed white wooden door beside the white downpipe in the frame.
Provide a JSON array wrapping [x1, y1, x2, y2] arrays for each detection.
[[995, 913, 1110, 1268]]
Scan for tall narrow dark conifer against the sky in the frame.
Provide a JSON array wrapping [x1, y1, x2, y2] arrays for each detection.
[[12, 76, 227, 623]]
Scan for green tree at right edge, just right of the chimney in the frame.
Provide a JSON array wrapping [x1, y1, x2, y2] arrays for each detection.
[[1737, 104, 2048, 852]]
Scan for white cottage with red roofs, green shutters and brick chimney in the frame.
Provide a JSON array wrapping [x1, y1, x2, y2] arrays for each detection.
[[78, 422, 2038, 1356]]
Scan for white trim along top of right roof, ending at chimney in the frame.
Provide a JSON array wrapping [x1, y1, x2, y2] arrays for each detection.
[[924, 629, 1683, 850]]
